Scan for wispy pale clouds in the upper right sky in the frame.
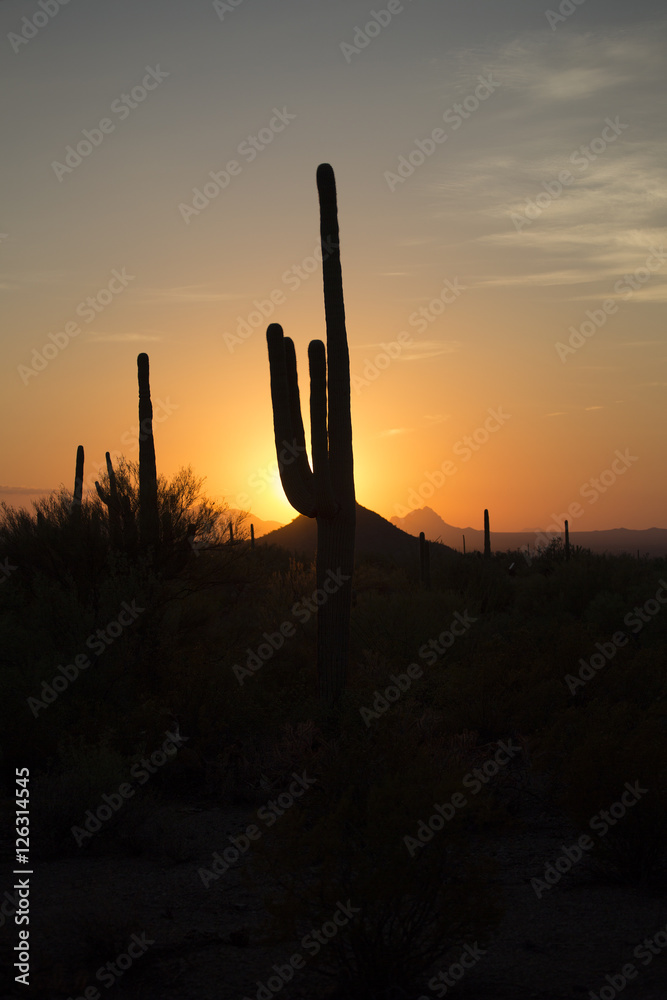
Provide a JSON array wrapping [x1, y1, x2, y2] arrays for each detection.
[[431, 20, 667, 302]]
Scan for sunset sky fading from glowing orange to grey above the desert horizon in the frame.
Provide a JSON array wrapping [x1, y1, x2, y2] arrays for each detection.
[[0, 0, 667, 531]]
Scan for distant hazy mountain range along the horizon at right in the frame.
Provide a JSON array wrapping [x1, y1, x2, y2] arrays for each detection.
[[391, 507, 667, 556]]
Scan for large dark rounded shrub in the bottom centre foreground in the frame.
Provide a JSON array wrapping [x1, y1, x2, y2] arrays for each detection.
[[250, 710, 501, 1000]]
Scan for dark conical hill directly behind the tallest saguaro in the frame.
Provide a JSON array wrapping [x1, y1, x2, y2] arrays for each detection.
[[263, 504, 448, 562]]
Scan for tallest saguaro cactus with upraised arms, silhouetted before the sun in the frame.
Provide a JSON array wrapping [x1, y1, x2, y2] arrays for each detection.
[[266, 163, 356, 705]]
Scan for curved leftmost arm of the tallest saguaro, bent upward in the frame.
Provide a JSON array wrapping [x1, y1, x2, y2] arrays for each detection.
[[266, 323, 316, 517]]
